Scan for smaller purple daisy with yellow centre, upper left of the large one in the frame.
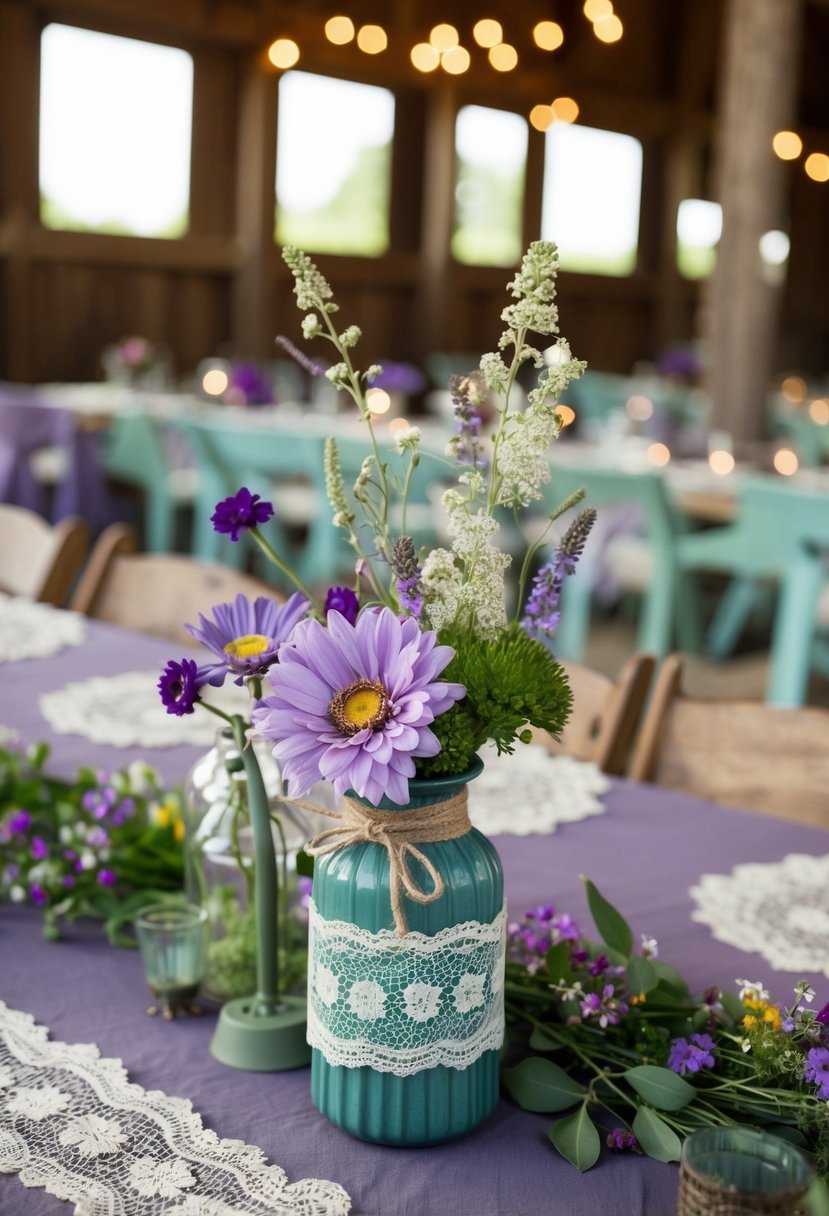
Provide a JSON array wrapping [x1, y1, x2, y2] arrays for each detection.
[[185, 591, 310, 686]]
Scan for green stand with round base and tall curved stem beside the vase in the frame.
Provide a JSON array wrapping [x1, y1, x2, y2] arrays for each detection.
[[210, 716, 311, 1073]]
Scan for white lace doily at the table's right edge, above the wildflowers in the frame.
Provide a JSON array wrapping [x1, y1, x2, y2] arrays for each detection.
[[690, 852, 829, 975]]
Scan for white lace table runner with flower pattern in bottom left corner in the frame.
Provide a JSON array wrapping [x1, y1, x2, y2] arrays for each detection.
[[0, 1001, 351, 1216]]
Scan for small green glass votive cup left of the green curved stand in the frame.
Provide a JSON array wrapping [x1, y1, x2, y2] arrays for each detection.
[[135, 903, 207, 1020]]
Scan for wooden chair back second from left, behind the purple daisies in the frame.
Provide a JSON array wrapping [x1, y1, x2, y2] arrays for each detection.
[[71, 524, 283, 647]]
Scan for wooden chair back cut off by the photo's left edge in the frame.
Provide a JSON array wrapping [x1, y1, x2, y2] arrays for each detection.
[[0, 503, 89, 608]]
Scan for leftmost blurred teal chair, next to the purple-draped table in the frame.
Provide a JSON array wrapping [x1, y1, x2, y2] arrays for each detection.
[[103, 412, 196, 553]]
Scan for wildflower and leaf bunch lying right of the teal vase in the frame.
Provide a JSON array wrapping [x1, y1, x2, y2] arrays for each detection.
[[503, 882, 829, 1186]]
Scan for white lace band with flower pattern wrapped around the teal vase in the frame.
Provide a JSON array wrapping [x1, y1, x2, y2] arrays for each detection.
[[308, 901, 507, 1076]]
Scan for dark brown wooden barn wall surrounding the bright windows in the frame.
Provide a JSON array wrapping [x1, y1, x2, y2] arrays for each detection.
[[0, 0, 829, 393]]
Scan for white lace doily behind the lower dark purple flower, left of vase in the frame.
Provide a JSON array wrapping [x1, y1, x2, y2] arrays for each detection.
[[39, 666, 250, 748]]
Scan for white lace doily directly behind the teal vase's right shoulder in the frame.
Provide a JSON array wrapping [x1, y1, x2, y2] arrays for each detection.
[[469, 745, 610, 835]]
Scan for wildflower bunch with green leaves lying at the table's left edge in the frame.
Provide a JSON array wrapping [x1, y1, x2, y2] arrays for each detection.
[[0, 743, 184, 945]]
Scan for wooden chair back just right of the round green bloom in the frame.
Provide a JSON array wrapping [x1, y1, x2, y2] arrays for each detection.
[[536, 654, 656, 776]]
